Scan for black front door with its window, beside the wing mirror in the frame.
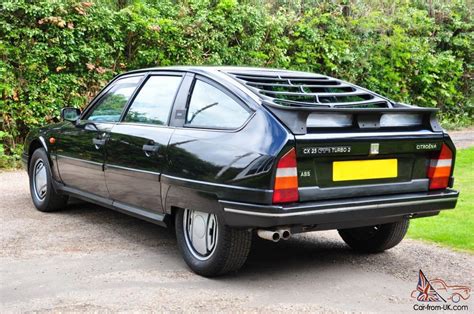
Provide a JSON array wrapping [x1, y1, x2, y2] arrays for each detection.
[[55, 76, 142, 197]]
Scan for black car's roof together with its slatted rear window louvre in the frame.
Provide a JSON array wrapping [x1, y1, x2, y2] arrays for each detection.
[[119, 65, 400, 108]]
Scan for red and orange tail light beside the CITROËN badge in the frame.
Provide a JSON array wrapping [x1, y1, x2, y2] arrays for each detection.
[[428, 144, 453, 190]]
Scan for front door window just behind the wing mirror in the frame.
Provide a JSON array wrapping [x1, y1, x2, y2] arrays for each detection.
[[86, 76, 142, 122]]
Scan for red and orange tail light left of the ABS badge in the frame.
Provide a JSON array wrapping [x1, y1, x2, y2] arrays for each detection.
[[273, 148, 298, 203]]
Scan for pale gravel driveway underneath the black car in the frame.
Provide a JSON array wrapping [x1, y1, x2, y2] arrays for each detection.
[[0, 171, 474, 312]]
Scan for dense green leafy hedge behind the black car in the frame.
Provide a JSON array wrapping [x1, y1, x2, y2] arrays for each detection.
[[0, 0, 474, 167]]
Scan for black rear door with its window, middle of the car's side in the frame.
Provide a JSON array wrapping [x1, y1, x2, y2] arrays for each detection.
[[105, 73, 182, 212]]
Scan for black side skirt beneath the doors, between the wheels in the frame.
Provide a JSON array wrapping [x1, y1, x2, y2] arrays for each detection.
[[55, 182, 169, 227]]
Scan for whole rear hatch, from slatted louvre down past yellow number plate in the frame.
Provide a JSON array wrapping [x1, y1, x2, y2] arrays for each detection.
[[226, 72, 454, 201]]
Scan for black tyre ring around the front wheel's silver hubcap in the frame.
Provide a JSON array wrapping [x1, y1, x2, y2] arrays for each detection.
[[28, 148, 53, 211]]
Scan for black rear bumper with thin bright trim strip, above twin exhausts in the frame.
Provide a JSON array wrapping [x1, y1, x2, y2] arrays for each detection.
[[219, 189, 459, 231]]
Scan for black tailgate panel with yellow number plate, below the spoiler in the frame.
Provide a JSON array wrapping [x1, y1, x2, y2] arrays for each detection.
[[296, 133, 443, 201]]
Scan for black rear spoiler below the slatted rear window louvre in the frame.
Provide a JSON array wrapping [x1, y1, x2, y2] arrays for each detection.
[[262, 100, 443, 135]]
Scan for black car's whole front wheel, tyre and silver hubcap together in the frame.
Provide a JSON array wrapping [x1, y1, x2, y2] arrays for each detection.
[[28, 148, 68, 212]]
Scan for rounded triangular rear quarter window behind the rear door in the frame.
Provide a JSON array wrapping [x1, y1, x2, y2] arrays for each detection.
[[186, 80, 250, 129]]
